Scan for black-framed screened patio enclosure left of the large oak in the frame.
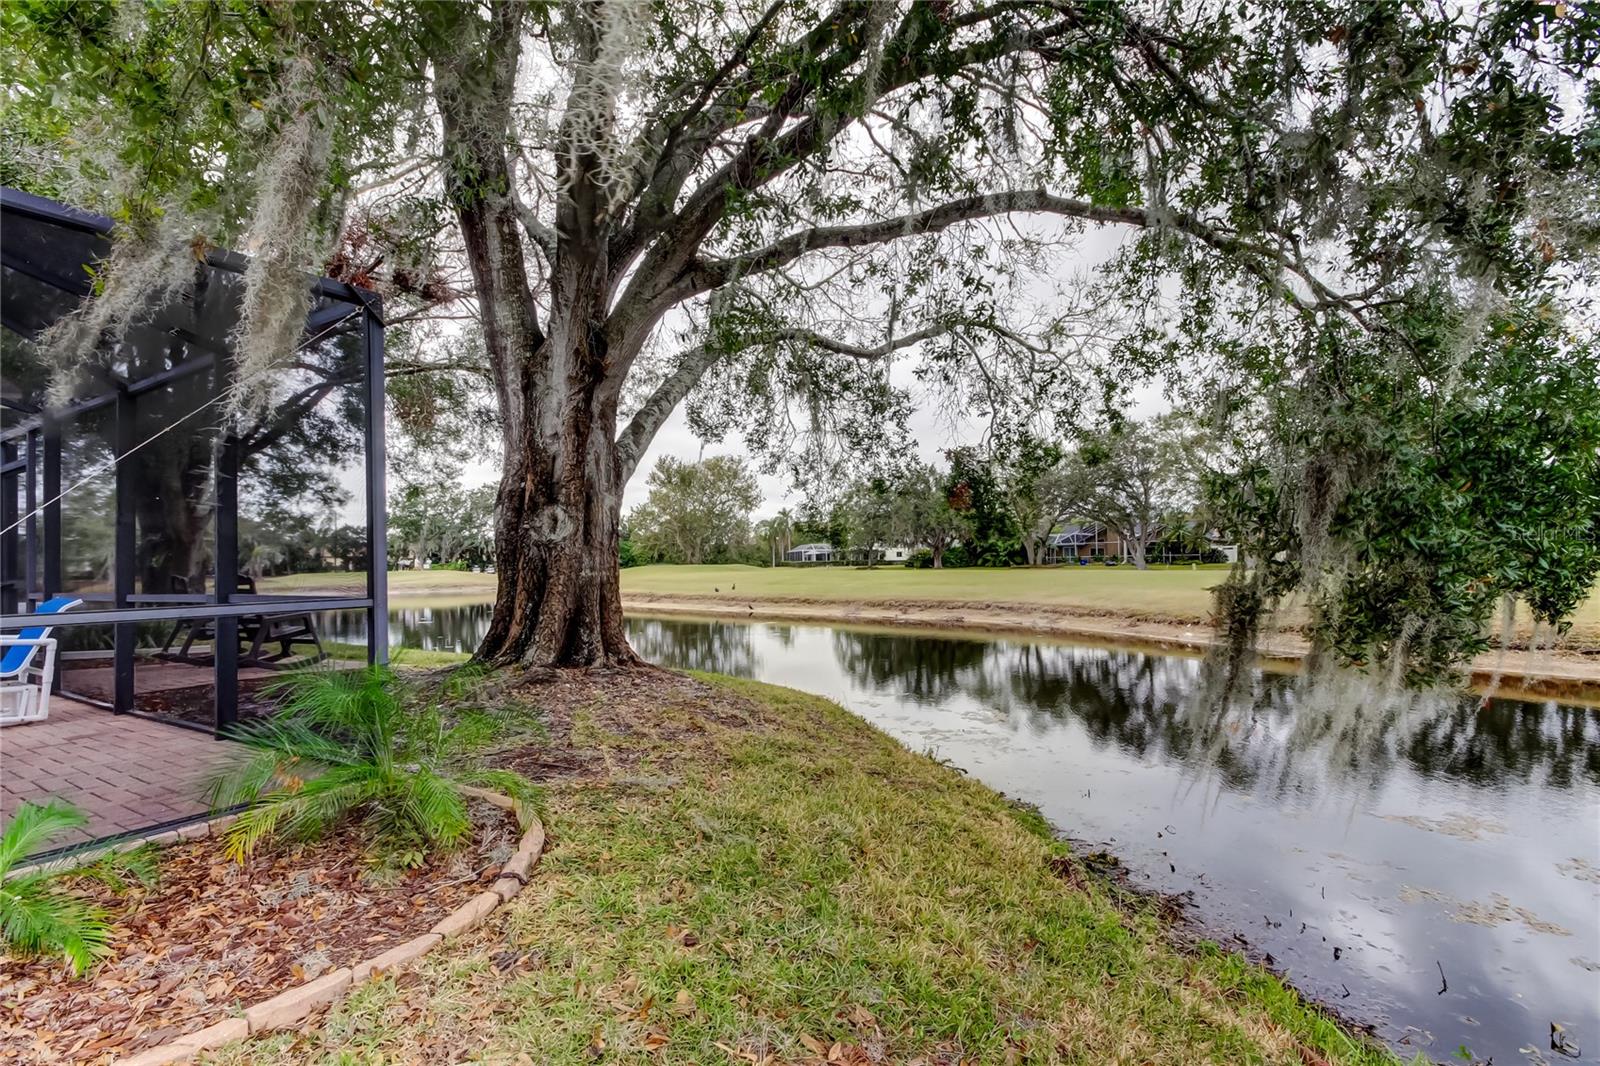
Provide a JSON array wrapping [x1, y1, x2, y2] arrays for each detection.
[[0, 189, 387, 744]]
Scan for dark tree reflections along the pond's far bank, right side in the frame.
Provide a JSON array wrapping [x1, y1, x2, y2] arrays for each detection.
[[832, 629, 1600, 794]]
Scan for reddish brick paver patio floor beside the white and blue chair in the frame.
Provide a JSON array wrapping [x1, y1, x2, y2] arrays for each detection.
[[0, 696, 230, 844]]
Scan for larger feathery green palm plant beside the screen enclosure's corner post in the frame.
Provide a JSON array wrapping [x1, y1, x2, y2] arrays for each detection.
[[210, 666, 534, 864]]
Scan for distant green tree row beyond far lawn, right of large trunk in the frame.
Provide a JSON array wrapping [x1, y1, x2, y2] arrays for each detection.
[[617, 413, 1222, 570]]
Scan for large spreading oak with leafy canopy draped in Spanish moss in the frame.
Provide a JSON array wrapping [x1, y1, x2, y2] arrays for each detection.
[[0, 0, 1600, 666]]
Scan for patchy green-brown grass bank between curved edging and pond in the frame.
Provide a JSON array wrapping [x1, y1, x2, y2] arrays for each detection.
[[228, 679, 1414, 1064]]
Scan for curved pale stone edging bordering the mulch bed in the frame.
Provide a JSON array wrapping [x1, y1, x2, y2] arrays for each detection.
[[117, 786, 544, 1066]]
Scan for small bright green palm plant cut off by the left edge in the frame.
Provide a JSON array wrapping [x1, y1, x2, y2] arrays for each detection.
[[0, 800, 154, 975]]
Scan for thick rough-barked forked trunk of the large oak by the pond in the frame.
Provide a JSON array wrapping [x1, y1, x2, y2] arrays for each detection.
[[435, 24, 642, 667]]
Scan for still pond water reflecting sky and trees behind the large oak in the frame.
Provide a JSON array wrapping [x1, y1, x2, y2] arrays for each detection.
[[328, 605, 1600, 1063]]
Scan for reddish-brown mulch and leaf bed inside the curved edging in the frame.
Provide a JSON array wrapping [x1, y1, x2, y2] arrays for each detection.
[[0, 802, 518, 1063]]
